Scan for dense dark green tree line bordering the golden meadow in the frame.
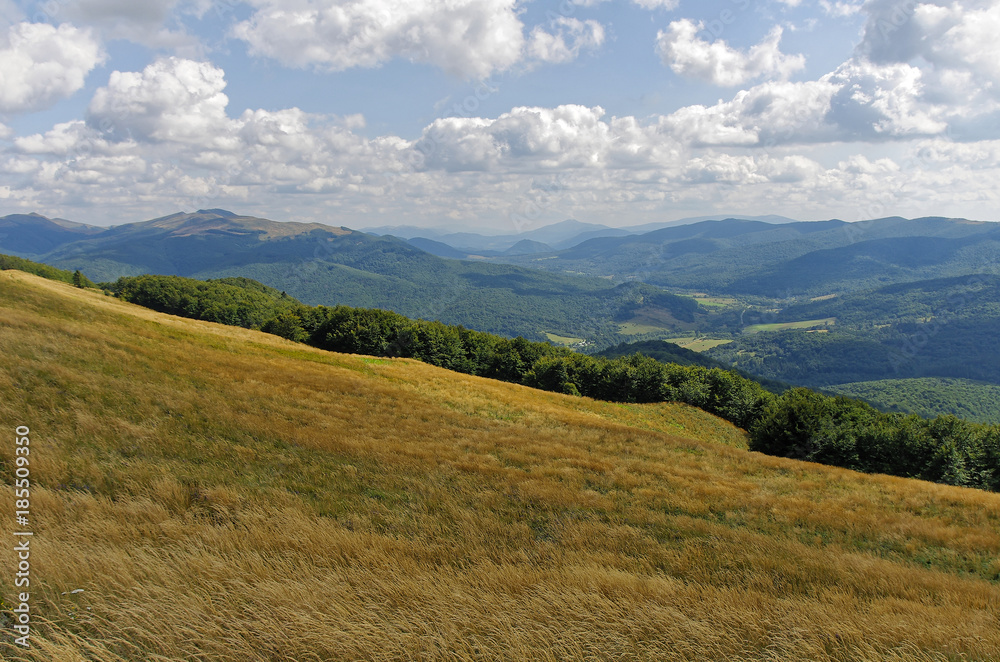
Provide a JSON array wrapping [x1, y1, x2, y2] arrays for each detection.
[[102, 276, 1000, 491]]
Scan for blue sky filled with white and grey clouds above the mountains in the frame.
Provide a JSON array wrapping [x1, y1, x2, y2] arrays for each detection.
[[0, 0, 1000, 233]]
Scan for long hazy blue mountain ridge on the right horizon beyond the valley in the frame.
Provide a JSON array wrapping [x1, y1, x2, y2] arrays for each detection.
[[494, 217, 1000, 299]]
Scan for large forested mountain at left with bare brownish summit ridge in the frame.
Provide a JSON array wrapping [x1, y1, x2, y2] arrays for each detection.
[[1, 209, 704, 344]]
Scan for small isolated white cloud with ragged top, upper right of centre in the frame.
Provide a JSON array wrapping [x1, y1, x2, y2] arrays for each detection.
[[656, 19, 805, 86]]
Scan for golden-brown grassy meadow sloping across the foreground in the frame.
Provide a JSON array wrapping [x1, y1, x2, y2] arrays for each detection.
[[0, 271, 1000, 662]]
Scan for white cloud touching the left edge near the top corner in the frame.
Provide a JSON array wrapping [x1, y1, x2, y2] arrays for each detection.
[[0, 23, 105, 112]]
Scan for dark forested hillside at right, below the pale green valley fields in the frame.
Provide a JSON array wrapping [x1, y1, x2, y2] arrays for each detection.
[[710, 274, 1000, 387]]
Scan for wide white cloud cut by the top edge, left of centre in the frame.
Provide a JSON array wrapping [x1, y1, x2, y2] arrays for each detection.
[[234, 0, 525, 78]]
